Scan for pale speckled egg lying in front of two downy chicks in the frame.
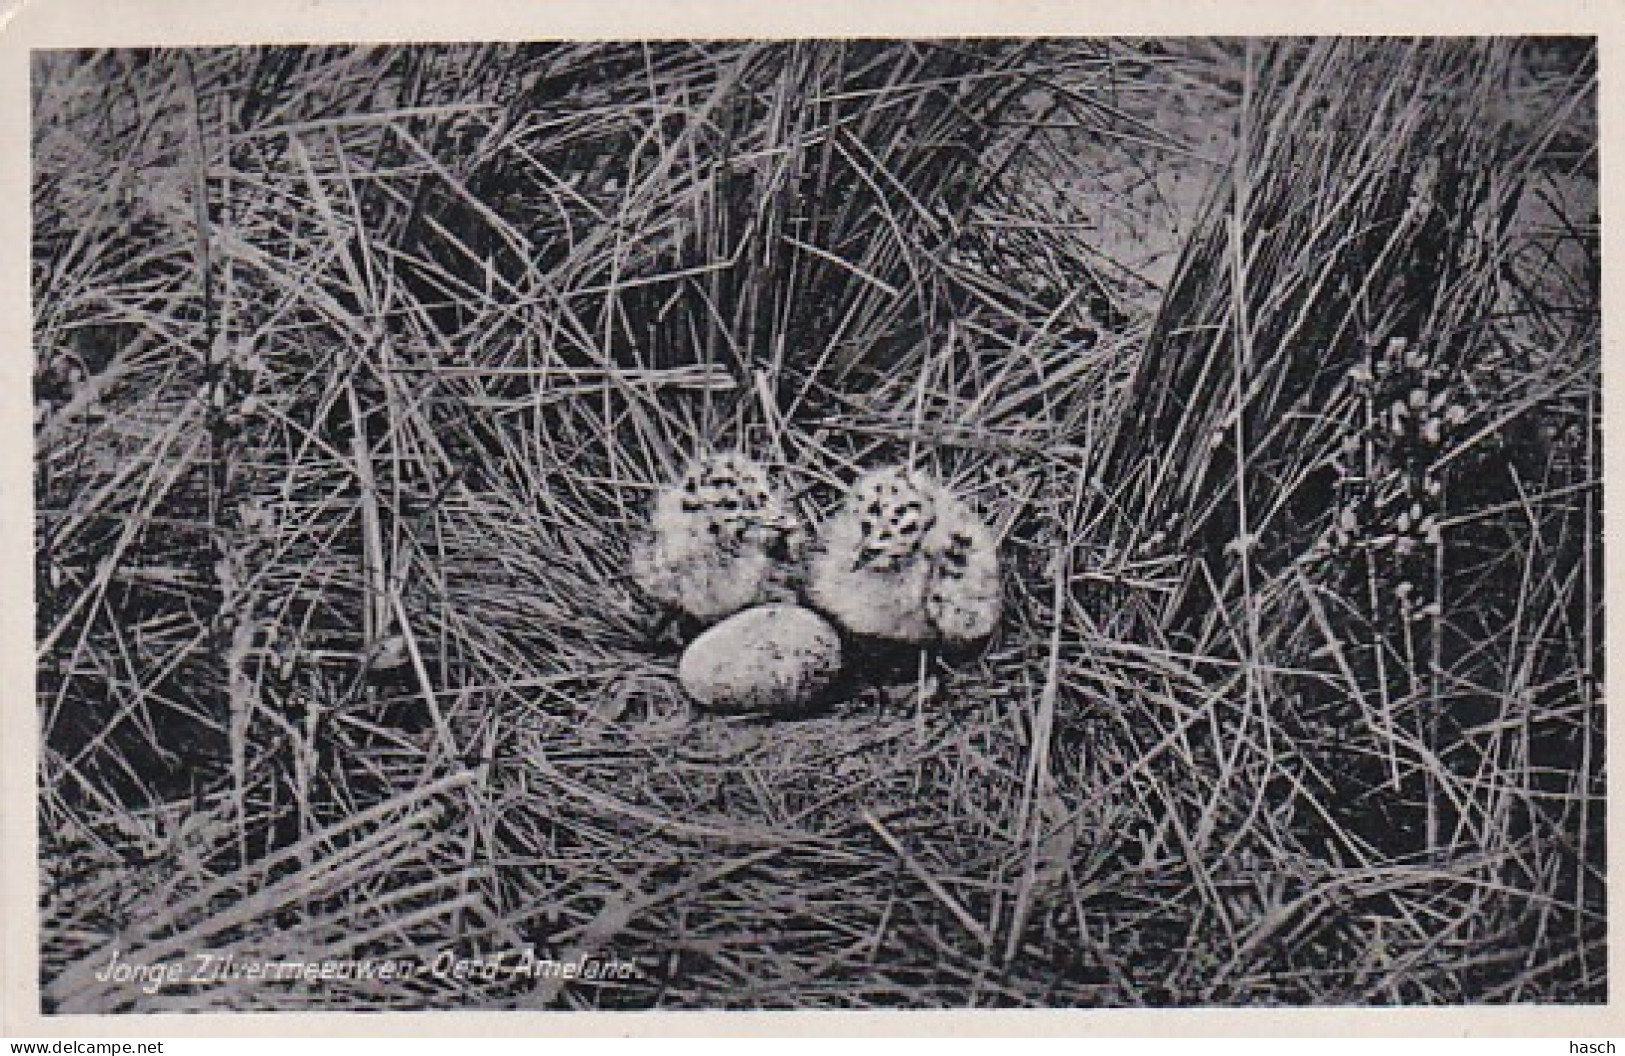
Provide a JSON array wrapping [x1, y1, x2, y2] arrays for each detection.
[[678, 604, 840, 718]]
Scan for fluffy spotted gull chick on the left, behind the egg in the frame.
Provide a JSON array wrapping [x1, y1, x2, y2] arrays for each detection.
[[632, 453, 803, 624]]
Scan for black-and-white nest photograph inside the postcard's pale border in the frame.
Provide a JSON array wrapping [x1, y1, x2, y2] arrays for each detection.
[[19, 18, 1610, 1024]]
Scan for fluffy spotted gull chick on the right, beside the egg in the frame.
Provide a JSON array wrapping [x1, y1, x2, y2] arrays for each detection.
[[806, 466, 1001, 645]]
